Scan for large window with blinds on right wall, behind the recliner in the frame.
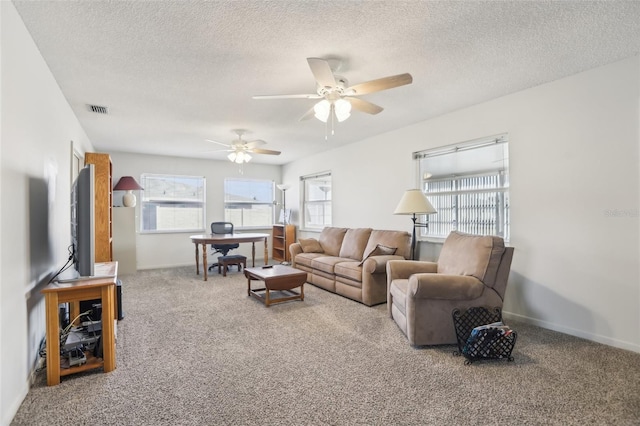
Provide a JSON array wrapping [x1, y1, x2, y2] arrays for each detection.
[[414, 135, 510, 240]]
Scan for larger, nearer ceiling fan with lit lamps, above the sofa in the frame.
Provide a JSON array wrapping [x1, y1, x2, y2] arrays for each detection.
[[253, 58, 413, 131]]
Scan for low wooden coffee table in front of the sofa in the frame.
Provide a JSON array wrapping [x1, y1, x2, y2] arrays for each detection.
[[244, 265, 307, 307]]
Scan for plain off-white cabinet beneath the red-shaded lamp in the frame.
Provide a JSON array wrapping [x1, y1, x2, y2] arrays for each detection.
[[112, 207, 138, 275]]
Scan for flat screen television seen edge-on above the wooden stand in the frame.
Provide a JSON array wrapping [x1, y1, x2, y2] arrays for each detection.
[[71, 164, 96, 277]]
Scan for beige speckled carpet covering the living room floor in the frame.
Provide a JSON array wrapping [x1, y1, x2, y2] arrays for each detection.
[[12, 268, 640, 426]]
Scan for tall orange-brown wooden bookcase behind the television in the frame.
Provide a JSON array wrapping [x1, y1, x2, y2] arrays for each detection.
[[84, 152, 113, 262]]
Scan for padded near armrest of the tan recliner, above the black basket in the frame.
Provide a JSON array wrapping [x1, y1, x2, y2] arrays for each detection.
[[407, 274, 484, 300]]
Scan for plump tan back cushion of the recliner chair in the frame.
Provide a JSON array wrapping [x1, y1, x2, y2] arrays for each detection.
[[438, 231, 504, 287]]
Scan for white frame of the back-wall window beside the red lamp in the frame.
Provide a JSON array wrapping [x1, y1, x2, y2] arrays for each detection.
[[140, 173, 207, 234]]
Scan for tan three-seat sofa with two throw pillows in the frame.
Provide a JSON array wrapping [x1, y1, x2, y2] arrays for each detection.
[[289, 227, 411, 306]]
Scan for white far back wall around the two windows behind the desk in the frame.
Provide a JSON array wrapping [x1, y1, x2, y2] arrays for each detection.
[[110, 152, 282, 272]]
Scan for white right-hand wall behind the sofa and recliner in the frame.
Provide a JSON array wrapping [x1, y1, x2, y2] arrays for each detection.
[[283, 56, 640, 352]]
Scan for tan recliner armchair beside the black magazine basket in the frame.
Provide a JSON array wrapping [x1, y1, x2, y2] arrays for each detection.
[[387, 231, 513, 346]]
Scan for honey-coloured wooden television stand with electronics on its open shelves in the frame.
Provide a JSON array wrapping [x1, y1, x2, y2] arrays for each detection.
[[42, 262, 118, 386]]
